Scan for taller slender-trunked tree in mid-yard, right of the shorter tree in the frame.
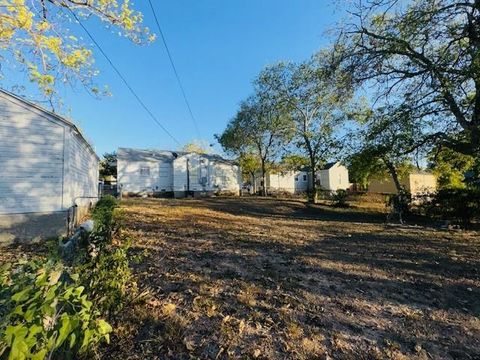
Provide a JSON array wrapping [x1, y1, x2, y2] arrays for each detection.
[[255, 51, 352, 202]]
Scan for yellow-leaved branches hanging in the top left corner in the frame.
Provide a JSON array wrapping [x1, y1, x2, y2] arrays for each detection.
[[0, 0, 154, 102]]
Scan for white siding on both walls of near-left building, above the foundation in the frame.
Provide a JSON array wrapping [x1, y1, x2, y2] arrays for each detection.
[[0, 91, 98, 214]]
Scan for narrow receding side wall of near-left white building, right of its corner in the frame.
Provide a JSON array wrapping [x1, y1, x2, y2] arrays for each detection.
[[64, 129, 99, 208]]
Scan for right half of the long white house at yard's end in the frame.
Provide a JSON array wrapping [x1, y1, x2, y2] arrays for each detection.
[[173, 153, 242, 197]]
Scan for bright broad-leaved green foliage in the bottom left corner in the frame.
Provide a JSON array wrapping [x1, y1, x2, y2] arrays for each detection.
[[0, 260, 112, 360]]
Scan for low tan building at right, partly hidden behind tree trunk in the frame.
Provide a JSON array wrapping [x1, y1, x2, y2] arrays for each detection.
[[368, 172, 437, 196]]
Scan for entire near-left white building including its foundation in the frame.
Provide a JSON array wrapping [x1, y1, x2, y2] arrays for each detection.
[[0, 90, 99, 243]]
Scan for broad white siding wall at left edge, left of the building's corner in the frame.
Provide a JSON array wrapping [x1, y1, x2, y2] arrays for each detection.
[[0, 93, 66, 214]]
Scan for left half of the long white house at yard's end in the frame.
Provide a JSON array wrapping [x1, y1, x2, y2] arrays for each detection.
[[117, 157, 173, 193]]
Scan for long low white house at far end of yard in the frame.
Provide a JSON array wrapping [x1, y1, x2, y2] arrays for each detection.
[[117, 148, 241, 197]]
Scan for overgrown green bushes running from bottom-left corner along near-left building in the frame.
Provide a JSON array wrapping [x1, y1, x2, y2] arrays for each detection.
[[0, 196, 135, 359]]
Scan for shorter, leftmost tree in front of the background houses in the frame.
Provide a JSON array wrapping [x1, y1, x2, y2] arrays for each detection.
[[216, 93, 292, 195]]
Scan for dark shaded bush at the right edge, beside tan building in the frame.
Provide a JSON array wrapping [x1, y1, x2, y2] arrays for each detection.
[[423, 189, 480, 226]]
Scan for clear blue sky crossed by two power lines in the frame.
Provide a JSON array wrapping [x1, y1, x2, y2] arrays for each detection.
[[4, 0, 341, 154]]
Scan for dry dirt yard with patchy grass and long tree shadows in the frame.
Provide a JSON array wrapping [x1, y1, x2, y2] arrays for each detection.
[[99, 198, 480, 359]]
